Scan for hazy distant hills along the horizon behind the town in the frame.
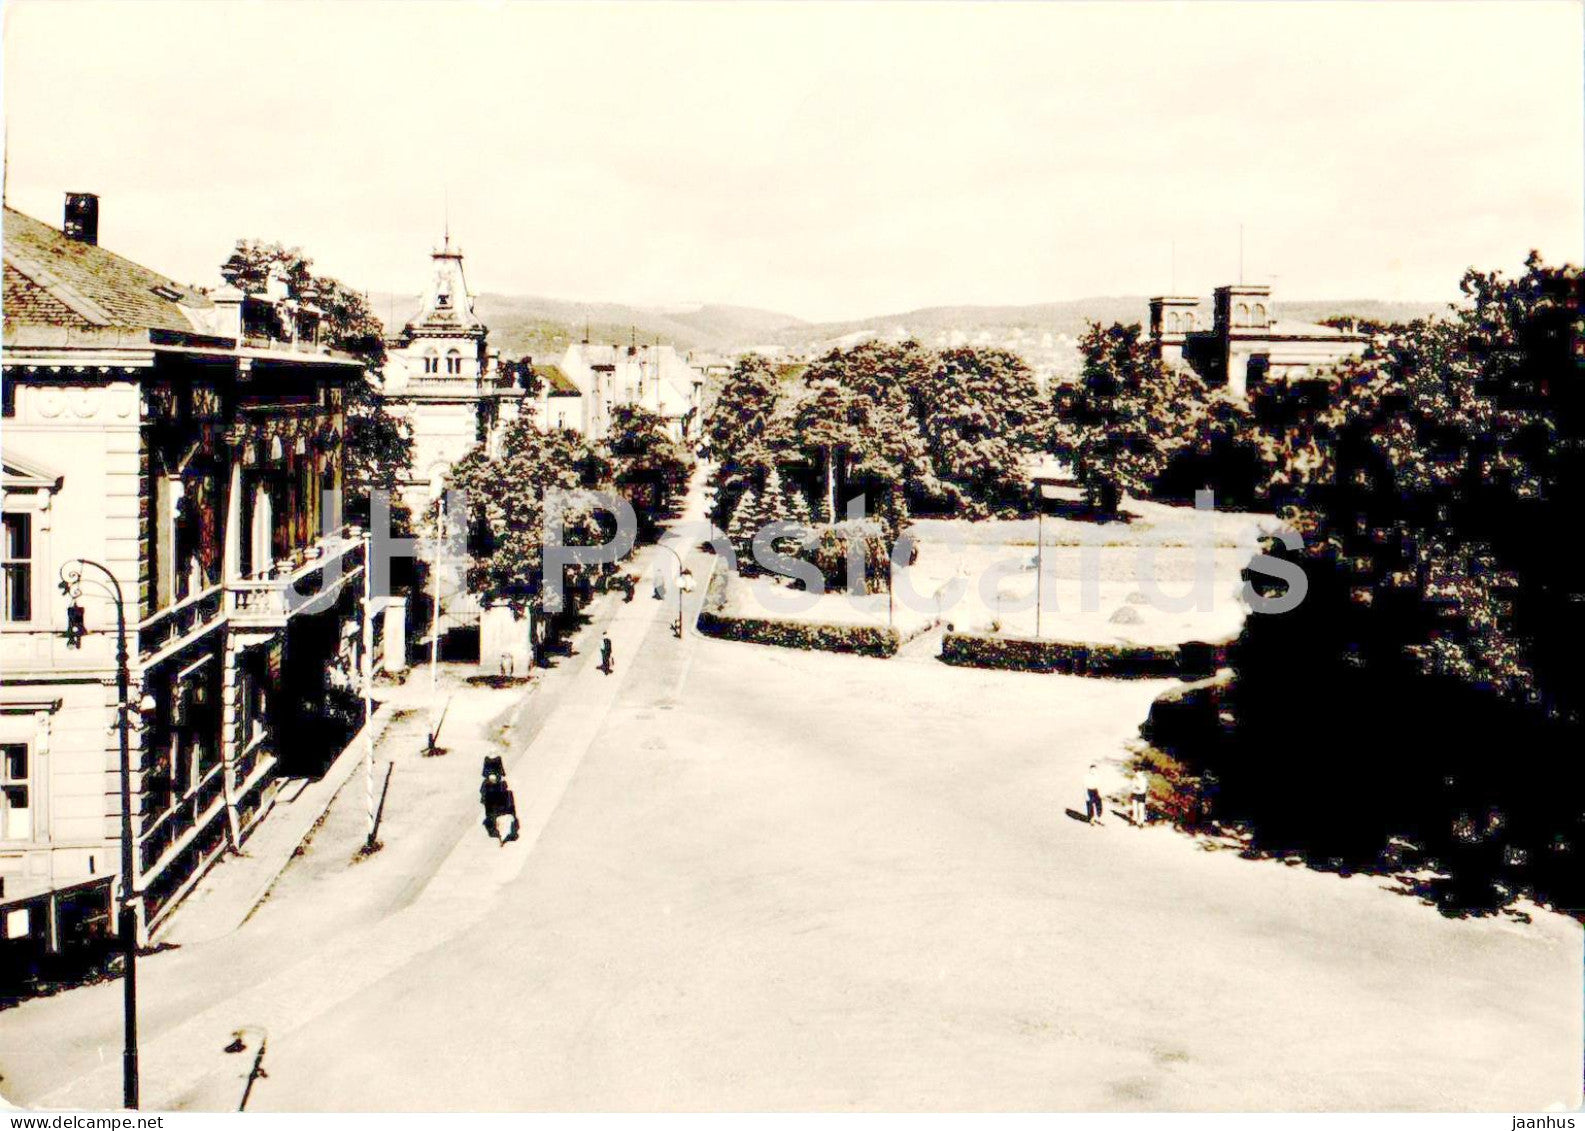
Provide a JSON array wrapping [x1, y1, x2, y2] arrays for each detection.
[[369, 293, 1447, 360]]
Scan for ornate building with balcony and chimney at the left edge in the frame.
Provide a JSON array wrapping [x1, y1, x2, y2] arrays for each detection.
[[0, 194, 365, 949]]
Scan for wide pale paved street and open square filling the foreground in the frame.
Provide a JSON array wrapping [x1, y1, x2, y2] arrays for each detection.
[[0, 510, 1582, 1110]]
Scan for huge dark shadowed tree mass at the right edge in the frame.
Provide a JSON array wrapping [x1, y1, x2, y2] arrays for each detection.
[[1191, 255, 1585, 912]]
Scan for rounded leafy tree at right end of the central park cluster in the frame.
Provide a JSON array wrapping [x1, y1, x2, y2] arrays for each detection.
[[915, 348, 1046, 516]]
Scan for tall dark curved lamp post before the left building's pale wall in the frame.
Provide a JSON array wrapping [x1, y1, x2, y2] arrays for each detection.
[[60, 558, 138, 1110]]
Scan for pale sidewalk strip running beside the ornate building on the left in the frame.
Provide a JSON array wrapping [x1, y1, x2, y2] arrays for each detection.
[[27, 502, 716, 1109]]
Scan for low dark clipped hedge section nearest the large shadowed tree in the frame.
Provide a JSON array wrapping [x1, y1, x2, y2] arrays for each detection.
[[941, 632, 1230, 680]]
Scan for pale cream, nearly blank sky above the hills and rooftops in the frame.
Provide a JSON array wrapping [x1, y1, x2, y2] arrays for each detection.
[[5, 0, 1585, 320]]
